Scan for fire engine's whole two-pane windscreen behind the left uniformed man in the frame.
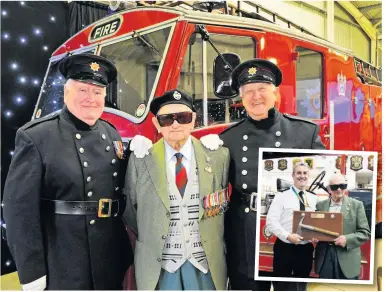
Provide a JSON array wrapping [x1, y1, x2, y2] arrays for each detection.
[[34, 26, 170, 118]]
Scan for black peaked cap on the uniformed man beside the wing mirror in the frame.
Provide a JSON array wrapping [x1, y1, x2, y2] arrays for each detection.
[[232, 59, 282, 90]]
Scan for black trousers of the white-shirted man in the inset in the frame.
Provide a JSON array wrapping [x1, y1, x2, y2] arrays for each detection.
[[273, 238, 314, 291]]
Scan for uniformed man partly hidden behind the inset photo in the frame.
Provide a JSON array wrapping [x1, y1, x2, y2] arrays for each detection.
[[220, 59, 325, 290]]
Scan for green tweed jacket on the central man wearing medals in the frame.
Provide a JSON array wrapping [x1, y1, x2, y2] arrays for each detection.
[[124, 137, 230, 290]]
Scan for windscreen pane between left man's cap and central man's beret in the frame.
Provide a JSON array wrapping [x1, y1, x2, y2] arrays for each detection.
[[100, 27, 170, 118]]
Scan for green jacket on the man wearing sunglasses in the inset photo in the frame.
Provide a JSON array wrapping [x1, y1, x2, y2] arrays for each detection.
[[315, 196, 370, 278]]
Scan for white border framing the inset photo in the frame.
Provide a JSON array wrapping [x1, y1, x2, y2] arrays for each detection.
[[255, 148, 378, 285]]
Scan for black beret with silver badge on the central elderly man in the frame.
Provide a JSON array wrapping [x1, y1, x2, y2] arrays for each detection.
[[150, 89, 194, 115]]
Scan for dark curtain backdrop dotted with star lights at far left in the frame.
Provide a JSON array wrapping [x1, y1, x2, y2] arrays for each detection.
[[1, 1, 108, 275]]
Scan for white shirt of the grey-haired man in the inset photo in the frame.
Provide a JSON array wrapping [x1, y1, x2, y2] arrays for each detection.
[[267, 186, 317, 244]]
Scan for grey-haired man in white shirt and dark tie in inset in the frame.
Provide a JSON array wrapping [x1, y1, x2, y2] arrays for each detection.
[[267, 162, 317, 291]]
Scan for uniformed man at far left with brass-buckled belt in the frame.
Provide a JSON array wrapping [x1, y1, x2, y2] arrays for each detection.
[[4, 54, 133, 290]]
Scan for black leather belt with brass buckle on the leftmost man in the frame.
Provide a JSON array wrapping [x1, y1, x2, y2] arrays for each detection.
[[41, 198, 126, 218]]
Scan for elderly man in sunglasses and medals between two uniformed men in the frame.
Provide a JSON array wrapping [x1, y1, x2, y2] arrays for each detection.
[[124, 90, 229, 290]]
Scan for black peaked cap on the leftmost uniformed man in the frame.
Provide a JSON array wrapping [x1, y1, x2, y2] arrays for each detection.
[[59, 54, 117, 87]]
